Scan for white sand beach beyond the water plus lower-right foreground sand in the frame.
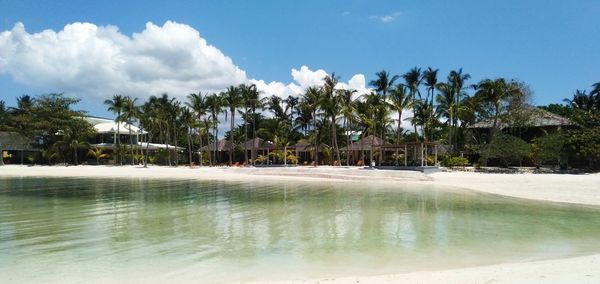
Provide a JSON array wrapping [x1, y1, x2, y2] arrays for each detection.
[[0, 165, 600, 283]]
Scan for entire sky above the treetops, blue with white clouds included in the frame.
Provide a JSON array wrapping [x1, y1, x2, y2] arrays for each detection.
[[0, 0, 600, 117]]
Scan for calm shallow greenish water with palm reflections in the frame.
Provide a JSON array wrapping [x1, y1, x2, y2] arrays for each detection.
[[0, 178, 600, 283]]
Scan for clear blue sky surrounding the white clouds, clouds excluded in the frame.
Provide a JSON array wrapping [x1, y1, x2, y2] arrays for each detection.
[[0, 0, 600, 115]]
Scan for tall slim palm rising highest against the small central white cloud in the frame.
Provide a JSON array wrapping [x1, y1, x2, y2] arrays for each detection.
[[319, 73, 340, 165]]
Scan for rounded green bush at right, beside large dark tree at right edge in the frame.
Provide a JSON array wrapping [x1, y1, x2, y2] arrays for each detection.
[[531, 133, 565, 167]]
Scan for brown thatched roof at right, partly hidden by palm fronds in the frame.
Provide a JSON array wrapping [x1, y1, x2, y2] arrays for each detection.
[[469, 107, 575, 129]]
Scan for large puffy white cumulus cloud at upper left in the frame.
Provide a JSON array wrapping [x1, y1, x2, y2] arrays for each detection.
[[0, 21, 247, 98]]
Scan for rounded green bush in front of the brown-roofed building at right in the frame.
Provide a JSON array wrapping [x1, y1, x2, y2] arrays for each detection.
[[479, 134, 530, 167]]
